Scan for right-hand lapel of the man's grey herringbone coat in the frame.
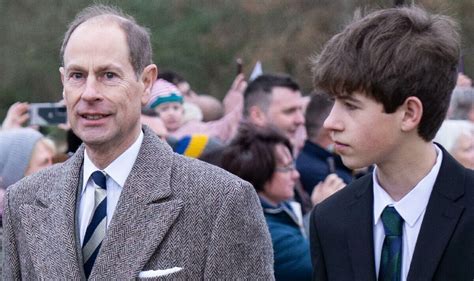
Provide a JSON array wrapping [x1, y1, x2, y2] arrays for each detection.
[[90, 128, 183, 279]]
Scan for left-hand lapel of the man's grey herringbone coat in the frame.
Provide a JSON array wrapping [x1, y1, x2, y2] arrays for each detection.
[[20, 149, 83, 279]]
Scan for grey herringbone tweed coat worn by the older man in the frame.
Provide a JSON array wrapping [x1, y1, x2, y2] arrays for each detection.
[[4, 127, 273, 280]]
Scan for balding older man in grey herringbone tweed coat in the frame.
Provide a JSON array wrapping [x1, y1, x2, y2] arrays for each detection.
[[4, 3, 273, 280]]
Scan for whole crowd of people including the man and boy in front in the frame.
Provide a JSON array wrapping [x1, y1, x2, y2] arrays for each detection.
[[0, 2, 474, 280]]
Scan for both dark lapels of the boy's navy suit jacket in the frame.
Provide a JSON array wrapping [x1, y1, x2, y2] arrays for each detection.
[[345, 147, 468, 280]]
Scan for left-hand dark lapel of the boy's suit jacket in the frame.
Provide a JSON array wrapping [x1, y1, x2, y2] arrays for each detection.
[[346, 175, 376, 281]]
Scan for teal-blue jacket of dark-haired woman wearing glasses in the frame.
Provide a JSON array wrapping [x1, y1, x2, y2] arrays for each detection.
[[260, 197, 313, 280]]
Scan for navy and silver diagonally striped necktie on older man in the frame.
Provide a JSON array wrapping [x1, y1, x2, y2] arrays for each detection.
[[82, 171, 107, 278]]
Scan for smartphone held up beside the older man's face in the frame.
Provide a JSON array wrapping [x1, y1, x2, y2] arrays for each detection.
[[29, 103, 67, 126]]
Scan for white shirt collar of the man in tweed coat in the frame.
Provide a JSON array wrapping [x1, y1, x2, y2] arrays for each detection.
[[82, 130, 143, 189]]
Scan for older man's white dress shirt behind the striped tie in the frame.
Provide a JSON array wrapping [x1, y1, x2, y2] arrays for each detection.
[[79, 131, 143, 245]]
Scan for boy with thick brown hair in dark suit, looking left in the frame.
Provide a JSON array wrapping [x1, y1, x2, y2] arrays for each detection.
[[311, 7, 474, 281]]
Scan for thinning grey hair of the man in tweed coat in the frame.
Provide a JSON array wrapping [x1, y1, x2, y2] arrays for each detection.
[[60, 5, 152, 78]]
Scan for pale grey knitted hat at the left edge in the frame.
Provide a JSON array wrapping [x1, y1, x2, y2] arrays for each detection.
[[0, 128, 43, 188]]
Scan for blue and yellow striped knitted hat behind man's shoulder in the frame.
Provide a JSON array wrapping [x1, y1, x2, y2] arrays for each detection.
[[170, 134, 223, 158]]
